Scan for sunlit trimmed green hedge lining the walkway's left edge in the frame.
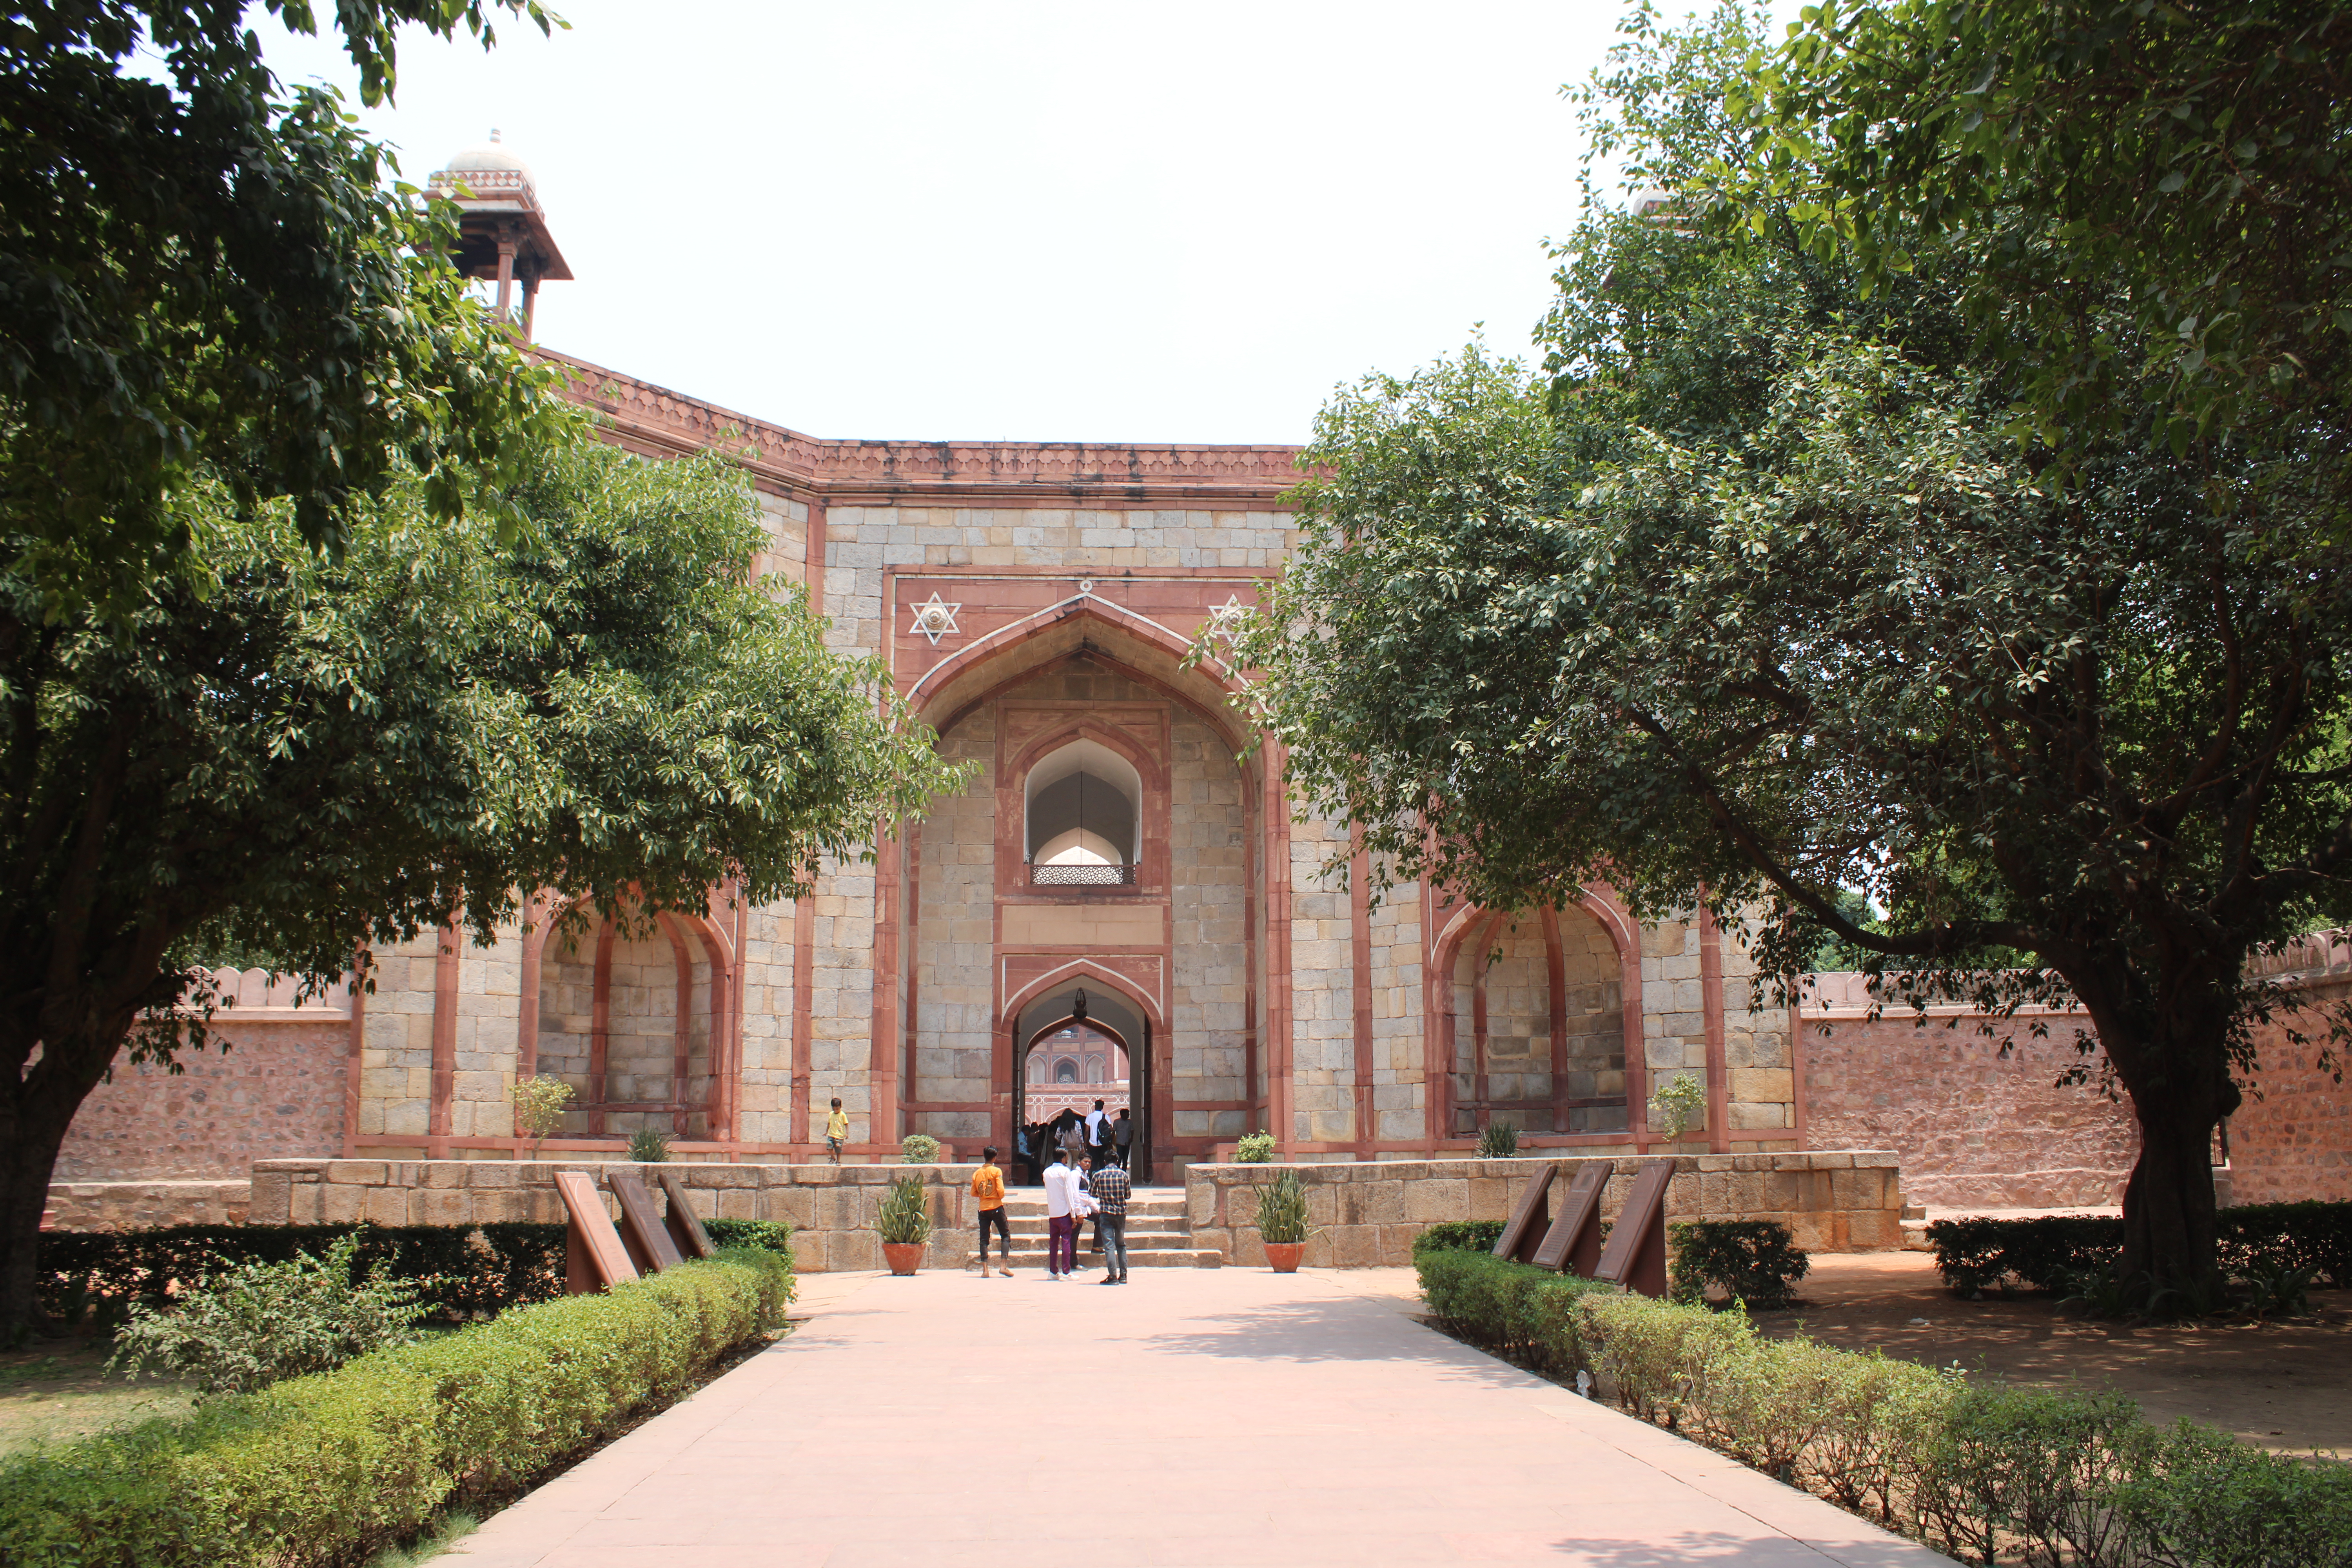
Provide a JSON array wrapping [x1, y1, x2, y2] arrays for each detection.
[[0, 1248, 793, 1568]]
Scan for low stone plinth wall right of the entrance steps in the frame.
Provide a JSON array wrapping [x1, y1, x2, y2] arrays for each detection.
[[1185, 1150, 1903, 1267]]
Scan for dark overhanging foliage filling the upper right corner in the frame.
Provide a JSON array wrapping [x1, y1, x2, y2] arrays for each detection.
[[1710, 0, 2352, 496]]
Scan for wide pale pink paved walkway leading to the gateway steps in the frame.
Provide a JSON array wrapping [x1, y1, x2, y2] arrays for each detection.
[[447, 1269, 1950, 1568]]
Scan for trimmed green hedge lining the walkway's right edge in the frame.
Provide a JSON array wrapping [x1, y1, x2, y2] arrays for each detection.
[[1416, 1248, 2352, 1568]]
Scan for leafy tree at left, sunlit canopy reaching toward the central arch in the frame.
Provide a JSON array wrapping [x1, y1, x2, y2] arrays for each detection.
[[0, 416, 953, 1328]]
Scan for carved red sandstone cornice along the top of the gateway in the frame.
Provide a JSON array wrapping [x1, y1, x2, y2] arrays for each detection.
[[532, 346, 1301, 510]]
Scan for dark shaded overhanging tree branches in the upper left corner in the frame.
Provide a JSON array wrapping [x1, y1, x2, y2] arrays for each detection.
[[0, 0, 569, 606]]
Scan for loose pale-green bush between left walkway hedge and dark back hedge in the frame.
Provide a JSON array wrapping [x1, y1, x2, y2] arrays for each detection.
[[106, 1234, 440, 1394]]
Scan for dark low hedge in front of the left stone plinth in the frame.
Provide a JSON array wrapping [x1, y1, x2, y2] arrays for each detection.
[[40, 1220, 793, 1323]]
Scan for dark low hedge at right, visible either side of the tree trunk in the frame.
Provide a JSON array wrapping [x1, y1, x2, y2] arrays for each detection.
[[1926, 1203, 2352, 1295]]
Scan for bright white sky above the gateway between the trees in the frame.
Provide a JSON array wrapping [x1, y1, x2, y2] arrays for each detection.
[[263, 0, 1750, 442]]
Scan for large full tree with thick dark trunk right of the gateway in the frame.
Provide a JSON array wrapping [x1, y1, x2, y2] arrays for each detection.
[[1225, 12, 2352, 1286]]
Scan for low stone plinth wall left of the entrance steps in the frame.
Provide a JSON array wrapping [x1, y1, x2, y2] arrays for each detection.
[[252, 1159, 978, 1274]]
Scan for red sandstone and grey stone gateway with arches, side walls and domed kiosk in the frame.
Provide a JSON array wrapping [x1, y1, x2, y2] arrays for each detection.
[[46, 135, 2352, 1218]]
